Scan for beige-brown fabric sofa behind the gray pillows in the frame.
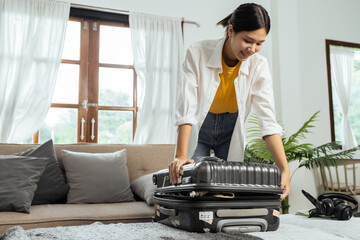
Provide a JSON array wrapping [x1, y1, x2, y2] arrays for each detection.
[[0, 144, 175, 234]]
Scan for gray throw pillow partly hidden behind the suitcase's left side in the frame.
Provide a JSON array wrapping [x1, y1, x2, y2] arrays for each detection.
[[130, 173, 156, 206]]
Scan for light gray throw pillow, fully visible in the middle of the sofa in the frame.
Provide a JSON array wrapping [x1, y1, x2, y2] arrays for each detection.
[[62, 149, 134, 203]]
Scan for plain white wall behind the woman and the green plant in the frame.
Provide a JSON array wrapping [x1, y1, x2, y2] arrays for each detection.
[[68, 0, 360, 212]]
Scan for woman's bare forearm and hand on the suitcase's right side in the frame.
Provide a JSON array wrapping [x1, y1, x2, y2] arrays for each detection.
[[264, 134, 290, 200]]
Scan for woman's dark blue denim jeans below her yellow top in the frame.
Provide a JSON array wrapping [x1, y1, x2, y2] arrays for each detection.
[[192, 112, 238, 162]]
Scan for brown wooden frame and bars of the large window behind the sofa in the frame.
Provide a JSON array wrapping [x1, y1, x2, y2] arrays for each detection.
[[33, 8, 138, 143]]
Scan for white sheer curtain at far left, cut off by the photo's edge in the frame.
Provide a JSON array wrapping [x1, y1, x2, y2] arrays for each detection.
[[0, 0, 70, 142]]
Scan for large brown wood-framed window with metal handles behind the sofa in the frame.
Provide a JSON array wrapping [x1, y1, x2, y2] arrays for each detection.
[[28, 8, 137, 144]]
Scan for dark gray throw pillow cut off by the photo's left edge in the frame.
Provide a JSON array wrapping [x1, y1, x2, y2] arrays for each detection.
[[0, 155, 48, 213]]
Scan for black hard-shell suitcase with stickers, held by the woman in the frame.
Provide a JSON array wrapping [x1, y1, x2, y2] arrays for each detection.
[[153, 157, 282, 232]]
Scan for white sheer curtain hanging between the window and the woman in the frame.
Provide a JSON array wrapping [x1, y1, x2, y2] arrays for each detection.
[[129, 12, 183, 144]]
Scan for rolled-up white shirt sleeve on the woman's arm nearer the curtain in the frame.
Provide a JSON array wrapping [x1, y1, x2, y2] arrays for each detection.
[[174, 46, 198, 126]]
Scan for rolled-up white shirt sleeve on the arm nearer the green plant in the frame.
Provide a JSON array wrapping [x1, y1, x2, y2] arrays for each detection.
[[251, 59, 282, 137]]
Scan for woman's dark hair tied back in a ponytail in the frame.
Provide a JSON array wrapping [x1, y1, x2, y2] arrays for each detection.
[[217, 3, 270, 33]]
